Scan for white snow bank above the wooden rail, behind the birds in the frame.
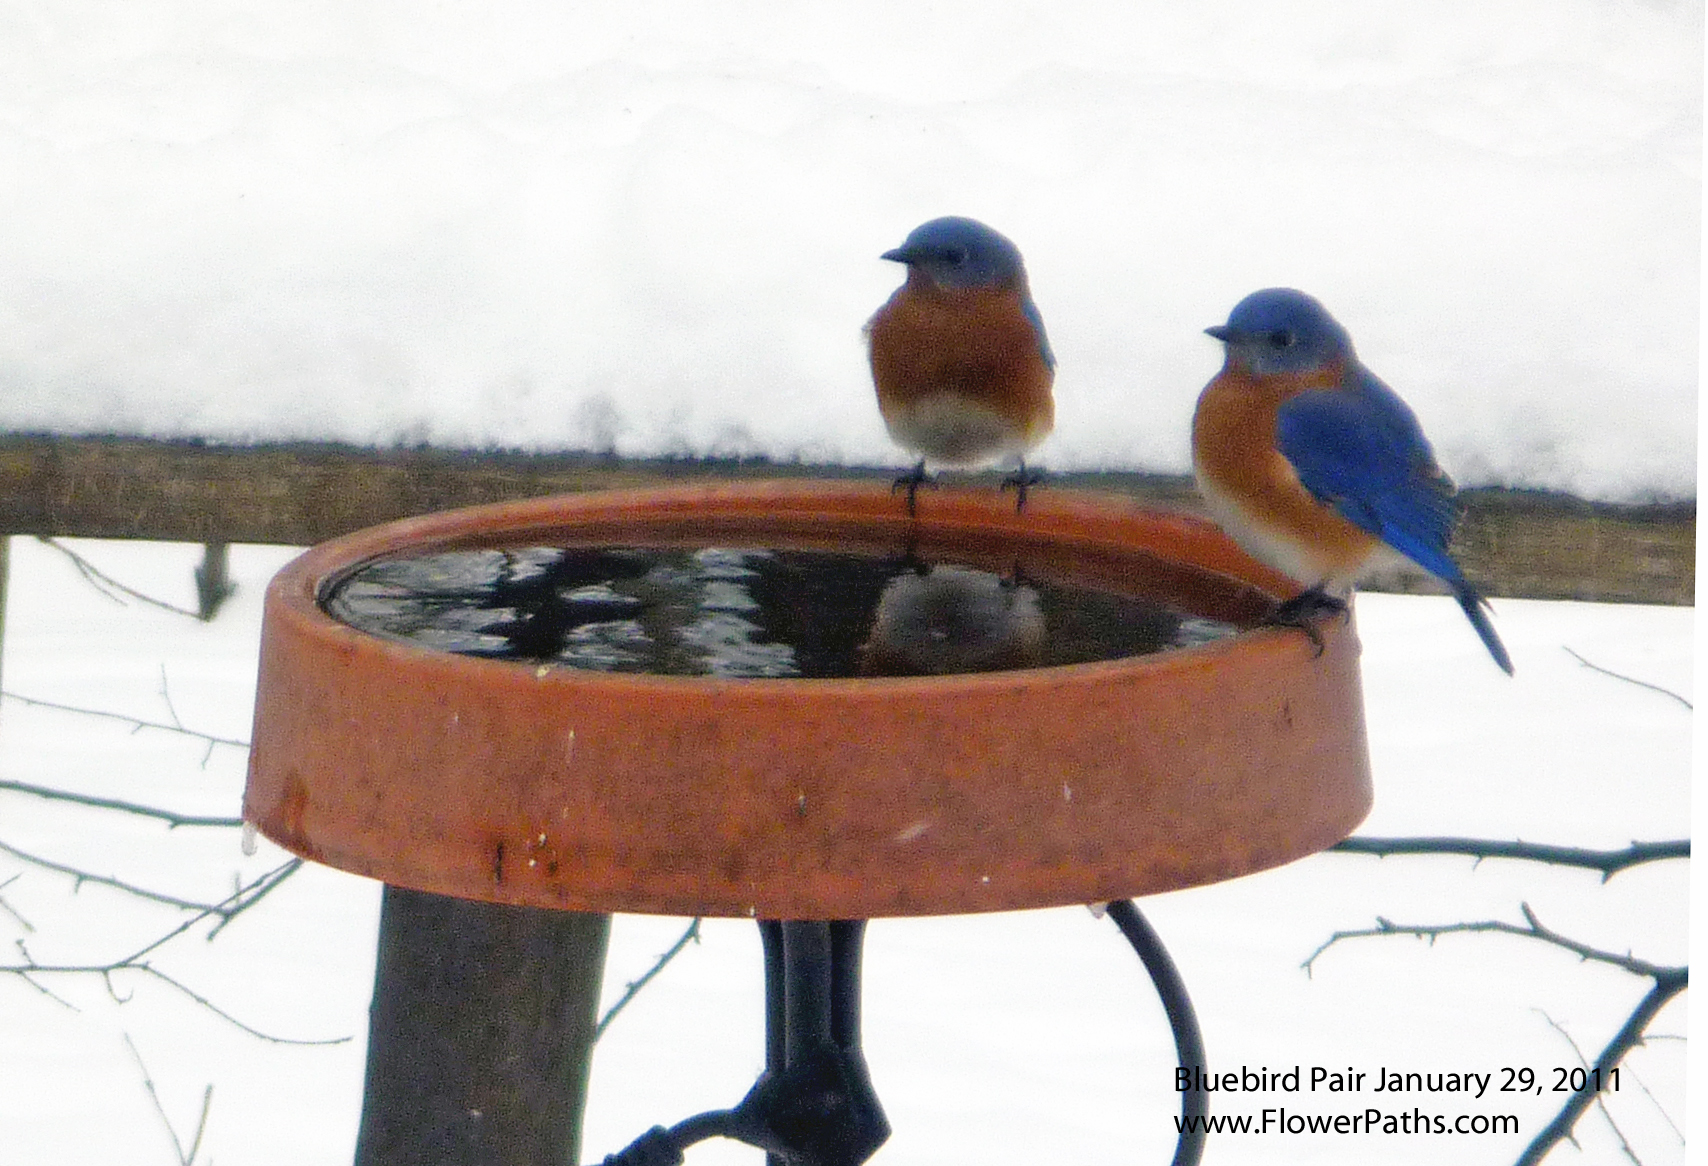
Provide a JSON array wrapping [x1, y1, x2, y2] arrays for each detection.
[[0, 0, 1703, 498]]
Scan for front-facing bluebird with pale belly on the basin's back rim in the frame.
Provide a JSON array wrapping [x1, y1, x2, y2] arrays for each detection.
[[866, 215, 1056, 514]]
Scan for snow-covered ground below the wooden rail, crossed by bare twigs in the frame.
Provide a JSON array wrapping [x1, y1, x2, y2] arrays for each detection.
[[0, 539, 1694, 1166]]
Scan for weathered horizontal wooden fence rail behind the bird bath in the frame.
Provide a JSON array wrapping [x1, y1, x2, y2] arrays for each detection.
[[0, 435, 1696, 604]]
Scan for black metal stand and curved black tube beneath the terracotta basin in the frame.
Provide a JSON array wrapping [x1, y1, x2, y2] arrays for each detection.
[[605, 900, 1209, 1166]]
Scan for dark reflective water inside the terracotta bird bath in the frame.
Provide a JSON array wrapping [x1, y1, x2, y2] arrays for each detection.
[[323, 546, 1238, 678]]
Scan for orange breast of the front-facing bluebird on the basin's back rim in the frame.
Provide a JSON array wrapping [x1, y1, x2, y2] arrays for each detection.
[[866, 278, 1056, 440]]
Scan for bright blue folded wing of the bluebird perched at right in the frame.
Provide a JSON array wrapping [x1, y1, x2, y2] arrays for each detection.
[[1276, 364, 1460, 582]]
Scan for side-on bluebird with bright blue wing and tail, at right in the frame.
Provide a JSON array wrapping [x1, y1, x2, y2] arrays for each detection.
[[1192, 287, 1512, 674]]
